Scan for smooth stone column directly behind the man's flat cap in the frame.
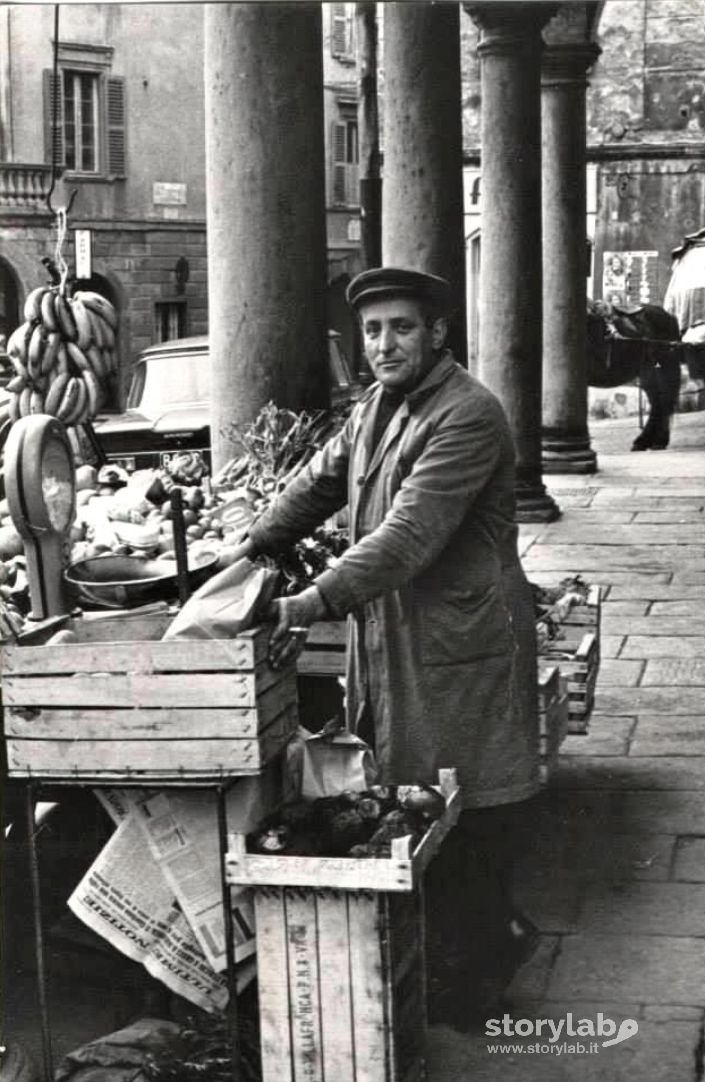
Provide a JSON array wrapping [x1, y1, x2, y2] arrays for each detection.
[[382, 2, 467, 365]]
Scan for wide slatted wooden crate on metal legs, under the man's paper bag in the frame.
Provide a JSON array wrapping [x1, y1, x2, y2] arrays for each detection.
[[1, 613, 298, 784]]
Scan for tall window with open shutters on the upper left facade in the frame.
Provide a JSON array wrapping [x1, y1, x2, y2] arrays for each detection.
[[44, 43, 125, 177]]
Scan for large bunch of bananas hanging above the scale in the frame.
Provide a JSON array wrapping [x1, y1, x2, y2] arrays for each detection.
[[8, 286, 118, 425]]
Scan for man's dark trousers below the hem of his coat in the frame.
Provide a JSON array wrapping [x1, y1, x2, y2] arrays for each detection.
[[425, 797, 536, 995]]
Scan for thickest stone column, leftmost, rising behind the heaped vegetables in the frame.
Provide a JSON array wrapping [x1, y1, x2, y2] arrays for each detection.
[[204, 3, 329, 469]]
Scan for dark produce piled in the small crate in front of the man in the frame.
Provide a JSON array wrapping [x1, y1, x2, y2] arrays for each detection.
[[248, 786, 445, 858]]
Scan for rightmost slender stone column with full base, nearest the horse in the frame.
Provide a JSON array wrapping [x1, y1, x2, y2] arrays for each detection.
[[541, 41, 599, 474]]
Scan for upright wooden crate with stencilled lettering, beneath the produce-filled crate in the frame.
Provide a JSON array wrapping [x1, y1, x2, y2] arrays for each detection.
[[254, 887, 426, 1082]]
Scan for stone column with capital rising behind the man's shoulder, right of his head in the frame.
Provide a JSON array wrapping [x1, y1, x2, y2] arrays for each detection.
[[465, 0, 560, 522]]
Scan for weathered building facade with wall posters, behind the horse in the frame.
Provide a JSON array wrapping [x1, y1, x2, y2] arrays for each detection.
[[462, 0, 705, 366]]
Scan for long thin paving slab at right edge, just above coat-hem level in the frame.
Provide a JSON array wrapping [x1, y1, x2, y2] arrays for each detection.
[[550, 757, 705, 790]]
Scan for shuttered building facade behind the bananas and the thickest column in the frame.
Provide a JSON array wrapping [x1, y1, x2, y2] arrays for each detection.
[[0, 3, 360, 407]]
